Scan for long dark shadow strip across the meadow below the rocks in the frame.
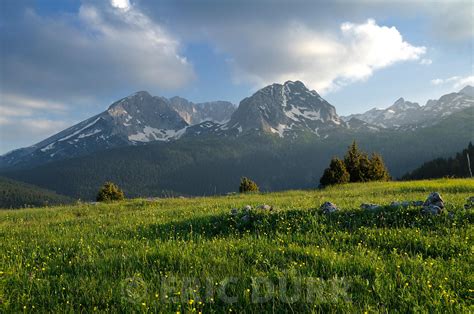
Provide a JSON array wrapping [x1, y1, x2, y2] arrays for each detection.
[[115, 207, 474, 241]]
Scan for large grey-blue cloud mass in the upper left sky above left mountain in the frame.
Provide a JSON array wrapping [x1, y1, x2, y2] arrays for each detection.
[[0, 0, 194, 100]]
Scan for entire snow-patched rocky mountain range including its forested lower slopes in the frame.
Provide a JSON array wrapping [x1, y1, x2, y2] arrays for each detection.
[[0, 81, 474, 198]]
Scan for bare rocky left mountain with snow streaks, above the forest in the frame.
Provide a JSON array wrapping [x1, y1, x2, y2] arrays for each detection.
[[0, 91, 235, 167]]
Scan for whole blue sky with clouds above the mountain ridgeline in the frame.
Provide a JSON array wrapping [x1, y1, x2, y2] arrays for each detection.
[[0, 0, 474, 154]]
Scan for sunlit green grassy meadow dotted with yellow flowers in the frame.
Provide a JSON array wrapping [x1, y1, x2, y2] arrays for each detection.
[[0, 179, 474, 313]]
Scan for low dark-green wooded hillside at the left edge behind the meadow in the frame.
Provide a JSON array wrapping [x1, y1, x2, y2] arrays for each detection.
[[0, 177, 73, 208]]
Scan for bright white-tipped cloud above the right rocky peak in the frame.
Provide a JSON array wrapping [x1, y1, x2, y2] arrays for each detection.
[[223, 19, 426, 92]]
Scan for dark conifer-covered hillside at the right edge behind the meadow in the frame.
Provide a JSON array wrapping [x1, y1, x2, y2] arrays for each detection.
[[402, 143, 474, 180]]
